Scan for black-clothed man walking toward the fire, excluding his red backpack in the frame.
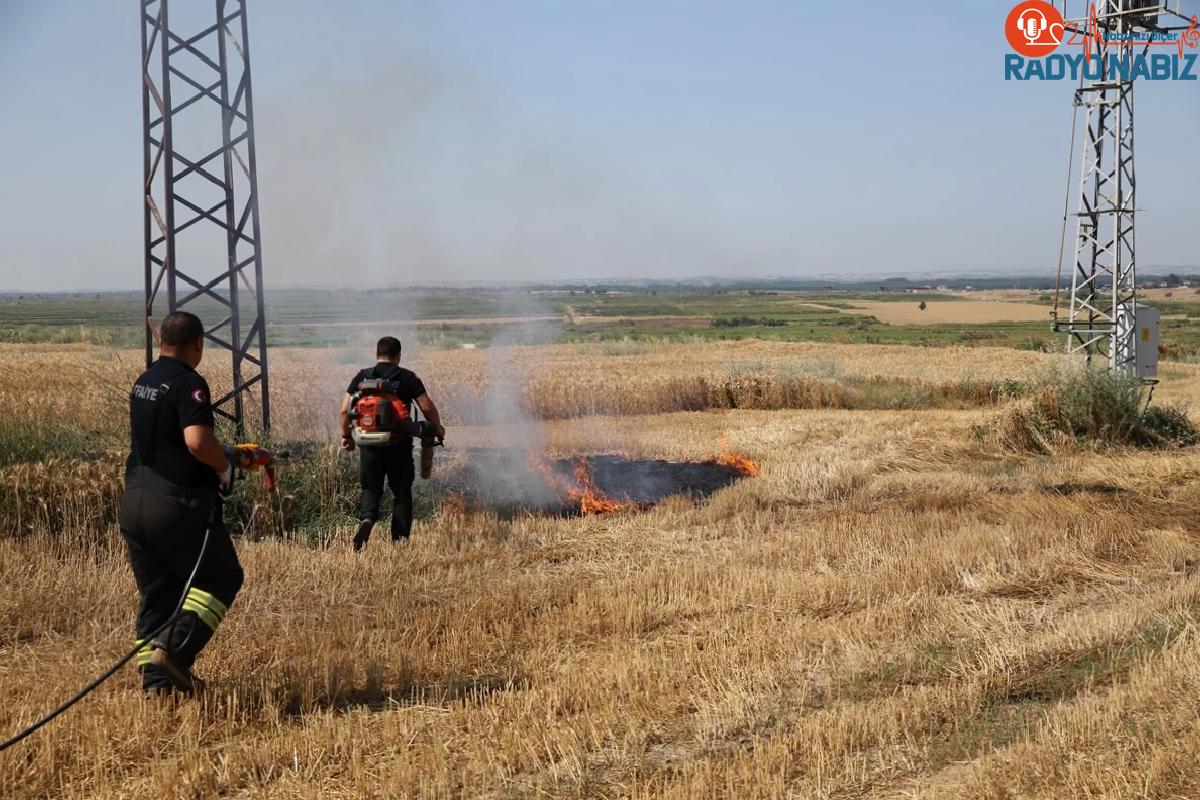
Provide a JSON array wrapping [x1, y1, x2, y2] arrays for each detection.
[[341, 336, 445, 551]]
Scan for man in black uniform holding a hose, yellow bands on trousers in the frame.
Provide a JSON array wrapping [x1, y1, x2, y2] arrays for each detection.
[[119, 312, 262, 693]]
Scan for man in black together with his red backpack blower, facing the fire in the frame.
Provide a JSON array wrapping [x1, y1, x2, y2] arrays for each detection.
[[340, 336, 445, 551]]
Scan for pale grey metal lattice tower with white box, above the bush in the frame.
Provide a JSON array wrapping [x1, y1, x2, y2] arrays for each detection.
[[1055, 0, 1183, 371]]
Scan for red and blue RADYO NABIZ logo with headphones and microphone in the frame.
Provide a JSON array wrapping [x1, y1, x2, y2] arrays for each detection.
[[1004, 0, 1200, 80]]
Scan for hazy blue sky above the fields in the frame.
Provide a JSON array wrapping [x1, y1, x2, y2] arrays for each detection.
[[0, 0, 1200, 290]]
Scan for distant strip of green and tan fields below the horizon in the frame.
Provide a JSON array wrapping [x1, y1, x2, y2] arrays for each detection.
[[7, 289, 1200, 352]]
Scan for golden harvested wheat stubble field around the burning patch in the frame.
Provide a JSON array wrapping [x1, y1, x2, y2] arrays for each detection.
[[0, 342, 1200, 799]]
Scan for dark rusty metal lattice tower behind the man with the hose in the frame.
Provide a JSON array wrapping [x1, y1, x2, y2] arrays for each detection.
[[138, 0, 271, 433]]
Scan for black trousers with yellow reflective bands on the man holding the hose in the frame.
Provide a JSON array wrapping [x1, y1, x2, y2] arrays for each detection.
[[118, 480, 244, 688]]
